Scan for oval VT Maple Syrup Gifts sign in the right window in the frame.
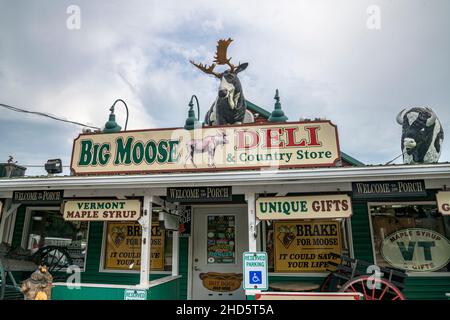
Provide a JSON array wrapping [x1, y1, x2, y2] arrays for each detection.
[[381, 228, 450, 272]]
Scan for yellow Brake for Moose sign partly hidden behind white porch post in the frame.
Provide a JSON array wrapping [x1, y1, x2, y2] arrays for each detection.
[[105, 222, 165, 271]]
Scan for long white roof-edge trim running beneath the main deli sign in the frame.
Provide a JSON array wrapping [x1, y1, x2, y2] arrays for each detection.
[[0, 163, 450, 191]]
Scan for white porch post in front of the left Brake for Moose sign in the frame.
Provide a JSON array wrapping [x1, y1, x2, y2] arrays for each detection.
[[139, 195, 153, 288]]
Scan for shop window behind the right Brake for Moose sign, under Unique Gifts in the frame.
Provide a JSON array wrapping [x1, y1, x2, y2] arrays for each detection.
[[265, 219, 350, 273]]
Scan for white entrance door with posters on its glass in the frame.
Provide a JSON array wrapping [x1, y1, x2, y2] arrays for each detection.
[[192, 206, 248, 300]]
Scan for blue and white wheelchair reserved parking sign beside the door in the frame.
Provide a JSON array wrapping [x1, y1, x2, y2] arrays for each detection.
[[243, 252, 269, 290]]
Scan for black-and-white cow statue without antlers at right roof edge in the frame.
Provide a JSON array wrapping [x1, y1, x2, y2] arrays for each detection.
[[397, 107, 444, 164]]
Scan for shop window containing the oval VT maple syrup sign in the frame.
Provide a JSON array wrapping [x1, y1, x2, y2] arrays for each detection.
[[369, 204, 450, 272]]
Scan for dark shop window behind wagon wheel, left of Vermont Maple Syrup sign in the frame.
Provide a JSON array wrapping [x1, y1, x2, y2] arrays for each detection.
[[26, 210, 89, 270]]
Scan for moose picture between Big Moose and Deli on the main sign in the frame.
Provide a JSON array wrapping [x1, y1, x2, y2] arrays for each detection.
[[184, 130, 229, 168]]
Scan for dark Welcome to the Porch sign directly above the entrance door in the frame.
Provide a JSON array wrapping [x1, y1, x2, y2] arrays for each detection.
[[166, 187, 233, 202]]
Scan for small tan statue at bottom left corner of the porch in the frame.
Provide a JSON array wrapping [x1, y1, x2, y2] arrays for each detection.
[[20, 266, 53, 300]]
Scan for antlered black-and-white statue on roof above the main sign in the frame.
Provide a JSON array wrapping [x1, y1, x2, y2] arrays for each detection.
[[190, 38, 250, 126]]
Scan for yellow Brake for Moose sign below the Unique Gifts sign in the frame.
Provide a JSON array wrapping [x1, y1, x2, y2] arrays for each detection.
[[273, 220, 342, 272]]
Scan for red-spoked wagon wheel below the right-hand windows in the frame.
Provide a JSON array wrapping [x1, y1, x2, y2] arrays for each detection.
[[339, 275, 405, 300]]
